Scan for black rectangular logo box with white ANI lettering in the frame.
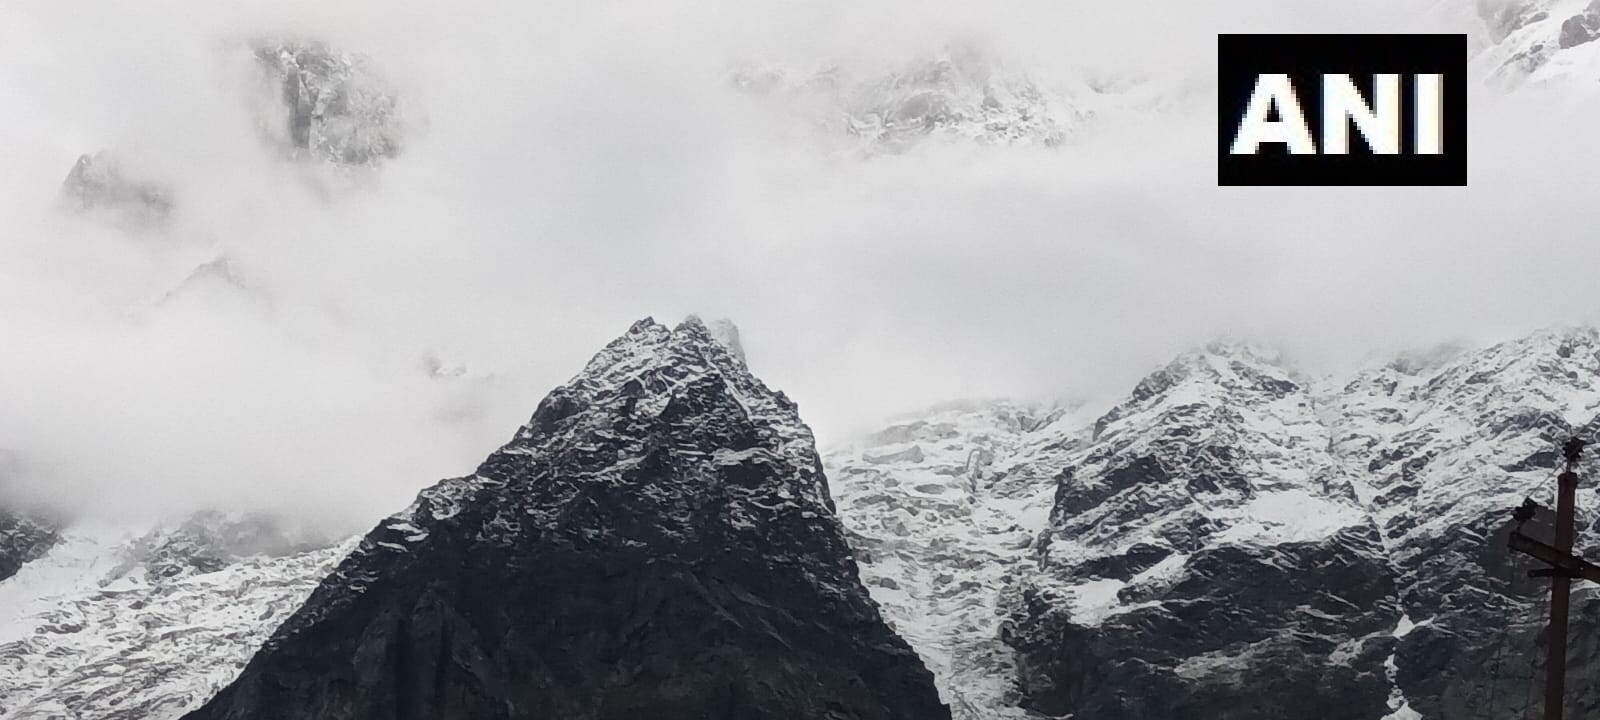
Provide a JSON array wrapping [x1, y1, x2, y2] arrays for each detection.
[[1218, 34, 1467, 186]]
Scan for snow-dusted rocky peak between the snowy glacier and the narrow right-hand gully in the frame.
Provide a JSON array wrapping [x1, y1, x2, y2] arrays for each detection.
[[1003, 346, 1400, 720]]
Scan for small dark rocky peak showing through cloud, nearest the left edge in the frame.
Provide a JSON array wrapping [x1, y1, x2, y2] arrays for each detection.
[[59, 150, 173, 229]]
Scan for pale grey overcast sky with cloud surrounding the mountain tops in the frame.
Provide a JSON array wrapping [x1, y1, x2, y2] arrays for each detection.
[[0, 0, 1600, 525]]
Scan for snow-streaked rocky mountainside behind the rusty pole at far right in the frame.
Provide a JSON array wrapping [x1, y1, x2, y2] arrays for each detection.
[[1339, 328, 1600, 718]]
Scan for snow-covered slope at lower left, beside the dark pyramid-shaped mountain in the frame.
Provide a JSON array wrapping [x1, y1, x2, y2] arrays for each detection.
[[0, 514, 350, 720]]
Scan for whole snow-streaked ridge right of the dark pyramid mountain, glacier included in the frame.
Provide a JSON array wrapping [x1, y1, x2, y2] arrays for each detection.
[[829, 328, 1600, 720]]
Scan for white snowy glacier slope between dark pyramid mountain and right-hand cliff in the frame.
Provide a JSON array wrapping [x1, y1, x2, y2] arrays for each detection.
[[824, 402, 1072, 720]]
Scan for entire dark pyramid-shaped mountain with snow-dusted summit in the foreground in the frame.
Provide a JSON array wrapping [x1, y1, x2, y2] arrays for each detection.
[[187, 320, 949, 720]]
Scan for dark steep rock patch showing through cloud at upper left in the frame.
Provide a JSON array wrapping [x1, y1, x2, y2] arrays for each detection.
[[254, 40, 403, 165]]
